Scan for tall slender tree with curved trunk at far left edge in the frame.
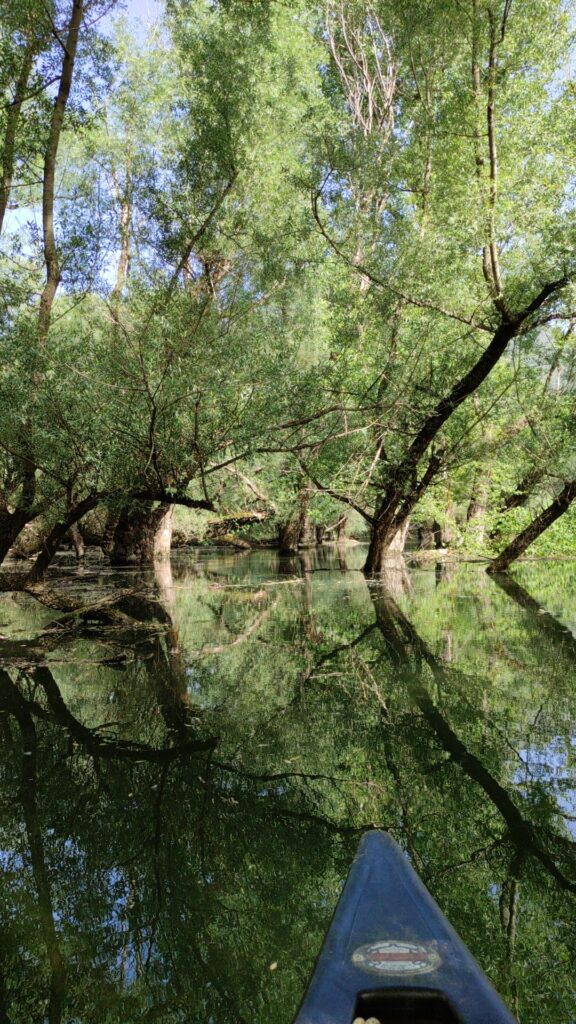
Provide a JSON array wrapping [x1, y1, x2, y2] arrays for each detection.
[[0, 0, 119, 577]]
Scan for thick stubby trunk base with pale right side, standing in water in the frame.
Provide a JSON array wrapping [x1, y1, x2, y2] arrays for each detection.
[[110, 503, 173, 565]]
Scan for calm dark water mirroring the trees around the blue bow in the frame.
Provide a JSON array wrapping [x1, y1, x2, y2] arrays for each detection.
[[0, 549, 576, 1024]]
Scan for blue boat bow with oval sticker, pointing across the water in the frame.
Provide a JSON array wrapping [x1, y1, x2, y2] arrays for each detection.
[[294, 831, 515, 1024]]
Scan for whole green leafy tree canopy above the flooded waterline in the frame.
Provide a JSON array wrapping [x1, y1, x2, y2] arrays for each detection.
[[0, 0, 576, 584]]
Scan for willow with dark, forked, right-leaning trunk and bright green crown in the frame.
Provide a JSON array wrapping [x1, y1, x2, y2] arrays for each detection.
[[313, 0, 574, 573]]
